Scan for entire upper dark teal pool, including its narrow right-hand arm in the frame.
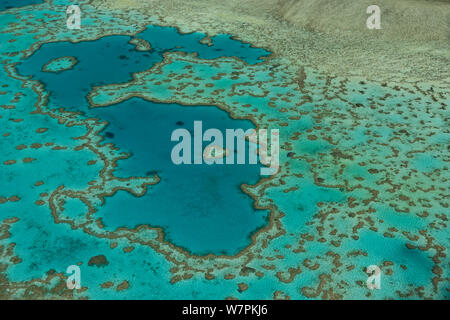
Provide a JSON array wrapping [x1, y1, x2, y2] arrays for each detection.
[[17, 26, 270, 111]]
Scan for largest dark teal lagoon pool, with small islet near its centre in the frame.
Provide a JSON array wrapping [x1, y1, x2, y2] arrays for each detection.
[[90, 98, 267, 255]]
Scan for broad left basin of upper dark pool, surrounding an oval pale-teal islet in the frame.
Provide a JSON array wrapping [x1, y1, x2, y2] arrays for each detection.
[[18, 36, 161, 112]]
